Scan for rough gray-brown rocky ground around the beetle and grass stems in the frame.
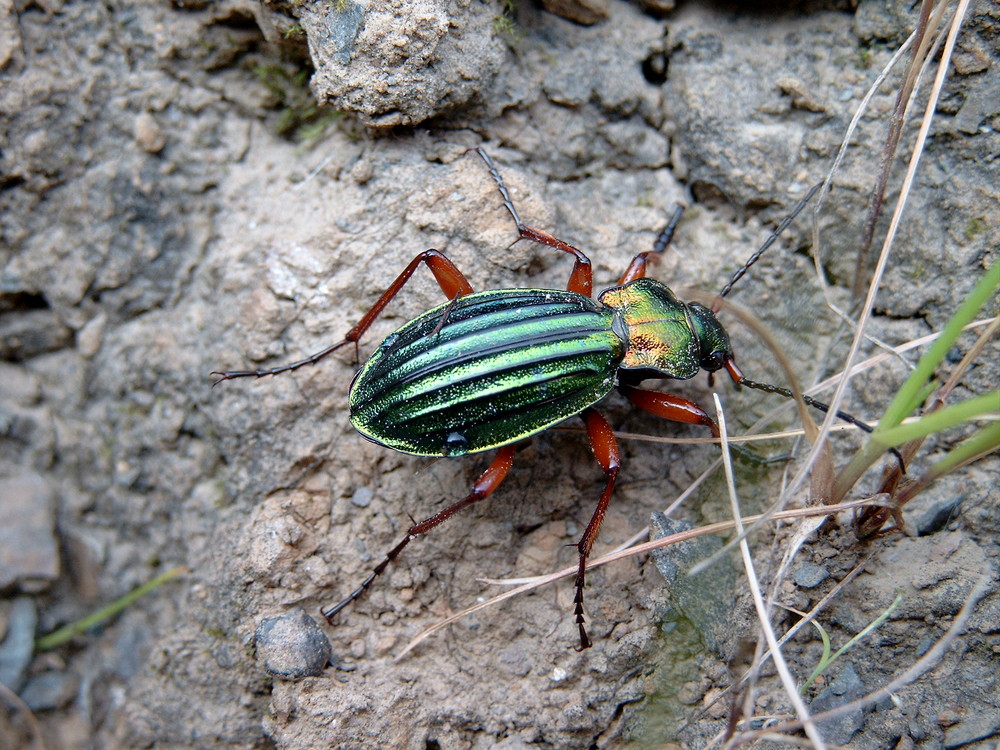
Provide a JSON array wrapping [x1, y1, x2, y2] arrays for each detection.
[[0, 0, 1000, 750]]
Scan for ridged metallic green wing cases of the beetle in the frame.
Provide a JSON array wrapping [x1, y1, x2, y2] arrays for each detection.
[[350, 289, 626, 456]]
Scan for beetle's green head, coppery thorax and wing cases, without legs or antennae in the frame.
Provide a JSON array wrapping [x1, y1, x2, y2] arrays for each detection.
[[350, 278, 729, 456]]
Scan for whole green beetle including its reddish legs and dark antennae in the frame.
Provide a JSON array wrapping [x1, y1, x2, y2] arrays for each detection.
[[212, 148, 871, 651]]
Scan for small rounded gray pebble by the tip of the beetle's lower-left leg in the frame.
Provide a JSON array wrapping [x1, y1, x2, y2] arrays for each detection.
[[254, 608, 331, 680]]
